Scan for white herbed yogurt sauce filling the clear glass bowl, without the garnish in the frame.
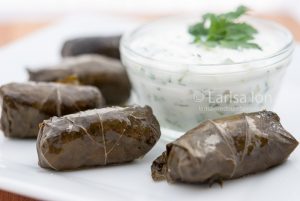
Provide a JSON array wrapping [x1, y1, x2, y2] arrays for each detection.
[[121, 14, 292, 139]]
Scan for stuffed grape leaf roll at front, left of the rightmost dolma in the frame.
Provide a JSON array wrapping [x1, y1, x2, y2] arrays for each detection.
[[37, 106, 160, 171]]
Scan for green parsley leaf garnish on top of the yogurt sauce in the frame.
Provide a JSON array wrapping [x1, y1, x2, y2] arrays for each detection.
[[189, 6, 261, 50]]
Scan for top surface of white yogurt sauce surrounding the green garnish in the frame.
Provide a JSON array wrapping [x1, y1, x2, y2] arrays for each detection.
[[130, 17, 286, 64]]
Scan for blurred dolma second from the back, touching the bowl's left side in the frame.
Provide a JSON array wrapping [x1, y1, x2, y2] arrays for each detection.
[[28, 55, 131, 105]]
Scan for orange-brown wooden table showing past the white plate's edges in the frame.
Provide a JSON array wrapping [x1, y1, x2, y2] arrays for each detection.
[[0, 12, 300, 201]]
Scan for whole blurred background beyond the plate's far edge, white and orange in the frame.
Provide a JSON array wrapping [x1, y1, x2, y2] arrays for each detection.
[[0, 0, 300, 45]]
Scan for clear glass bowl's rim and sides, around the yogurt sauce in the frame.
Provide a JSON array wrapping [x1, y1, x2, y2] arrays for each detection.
[[120, 16, 293, 139]]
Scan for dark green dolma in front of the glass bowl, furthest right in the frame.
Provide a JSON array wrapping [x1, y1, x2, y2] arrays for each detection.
[[151, 111, 298, 184]]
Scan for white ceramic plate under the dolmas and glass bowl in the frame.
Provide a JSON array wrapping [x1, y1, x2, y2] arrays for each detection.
[[0, 16, 300, 201]]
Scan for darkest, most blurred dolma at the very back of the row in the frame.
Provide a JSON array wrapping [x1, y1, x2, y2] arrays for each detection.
[[61, 35, 121, 59]]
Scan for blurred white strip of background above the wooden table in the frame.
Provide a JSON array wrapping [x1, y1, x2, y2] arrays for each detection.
[[0, 0, 299, 19]]
